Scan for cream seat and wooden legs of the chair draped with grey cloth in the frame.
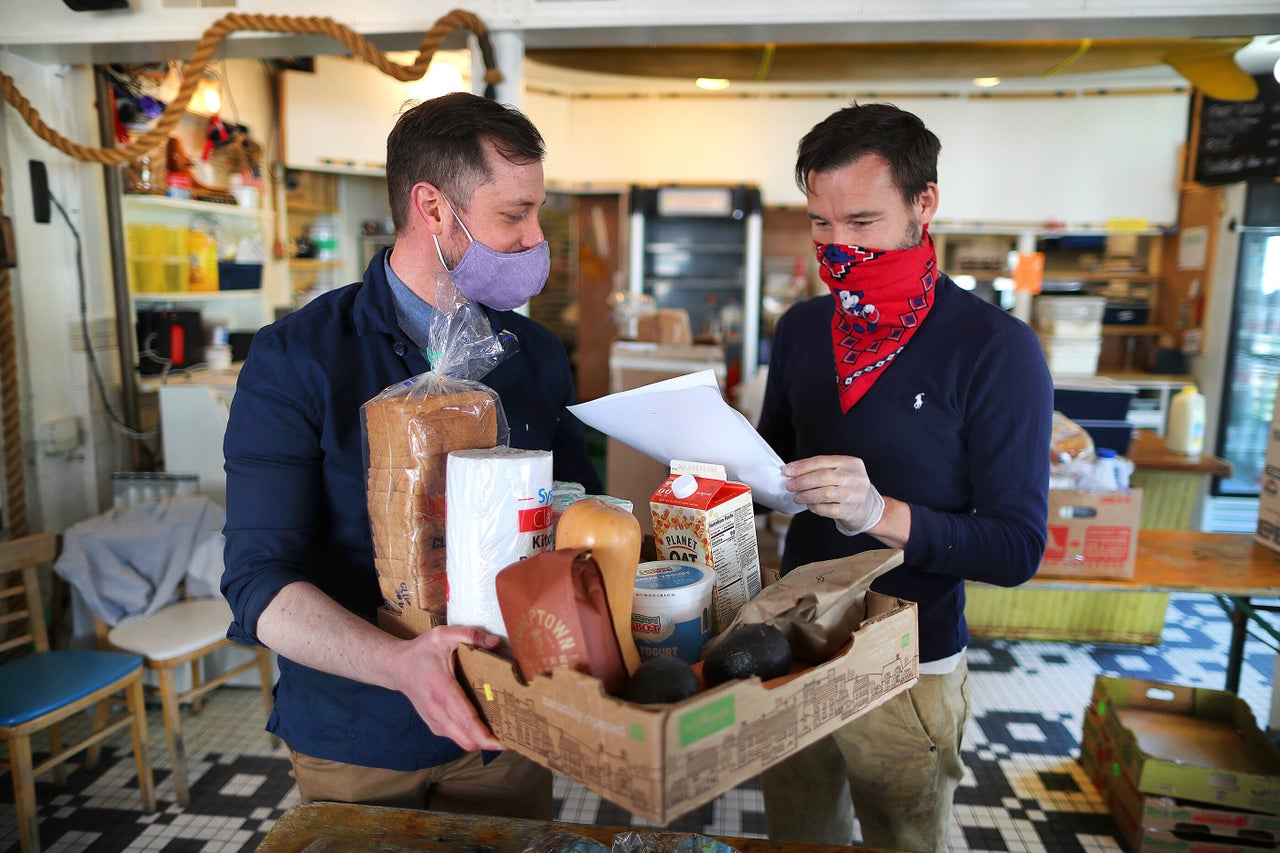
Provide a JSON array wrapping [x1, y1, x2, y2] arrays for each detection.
[[99, 598, 274, 806]]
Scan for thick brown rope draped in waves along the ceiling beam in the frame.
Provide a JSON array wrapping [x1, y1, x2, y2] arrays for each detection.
[[0, 9, 502, 165]]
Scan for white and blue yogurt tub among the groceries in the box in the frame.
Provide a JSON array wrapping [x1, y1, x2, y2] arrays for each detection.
[[631, 560, 716, 663]]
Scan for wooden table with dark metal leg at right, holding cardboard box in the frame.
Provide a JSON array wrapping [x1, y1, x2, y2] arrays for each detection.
[[1023, 530, 1280, 693]]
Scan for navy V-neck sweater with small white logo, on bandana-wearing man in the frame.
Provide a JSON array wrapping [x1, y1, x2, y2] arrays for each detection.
[[759, 275, 1053, 662]]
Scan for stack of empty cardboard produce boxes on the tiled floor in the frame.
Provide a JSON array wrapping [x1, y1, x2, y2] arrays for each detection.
[[1080, 676, 1280, 853]]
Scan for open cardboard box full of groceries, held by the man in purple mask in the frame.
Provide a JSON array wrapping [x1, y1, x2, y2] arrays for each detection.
[[458, 592, 919, 824]]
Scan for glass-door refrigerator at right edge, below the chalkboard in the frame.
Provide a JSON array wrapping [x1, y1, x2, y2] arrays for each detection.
[[1196, 182, 1280, 498]]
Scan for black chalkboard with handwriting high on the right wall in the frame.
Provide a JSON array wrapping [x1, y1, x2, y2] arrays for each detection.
[[1196, 74, 1280, 184]]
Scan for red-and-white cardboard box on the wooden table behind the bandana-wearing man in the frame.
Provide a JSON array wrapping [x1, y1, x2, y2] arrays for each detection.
[[1036, 488, 1142, 580]]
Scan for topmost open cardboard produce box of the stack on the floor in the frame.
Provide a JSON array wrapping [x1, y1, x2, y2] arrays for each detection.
[[1089, 676, 1280, 815]]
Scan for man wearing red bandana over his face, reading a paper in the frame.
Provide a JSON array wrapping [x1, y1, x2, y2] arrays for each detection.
[[759, 104, 1053, 850]]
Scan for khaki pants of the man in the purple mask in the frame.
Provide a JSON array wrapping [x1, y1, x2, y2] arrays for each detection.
[[289, 749, 556, 821]]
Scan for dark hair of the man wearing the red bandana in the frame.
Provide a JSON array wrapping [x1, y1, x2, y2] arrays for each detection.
[[796, 104, 942, 204]]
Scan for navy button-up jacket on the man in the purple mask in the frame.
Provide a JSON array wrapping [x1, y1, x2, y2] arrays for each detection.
[[223, 252, 602, 770]]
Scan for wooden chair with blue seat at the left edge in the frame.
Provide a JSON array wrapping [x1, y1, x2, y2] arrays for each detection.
[[0, 533, 156, 853]]
